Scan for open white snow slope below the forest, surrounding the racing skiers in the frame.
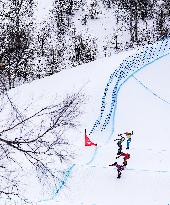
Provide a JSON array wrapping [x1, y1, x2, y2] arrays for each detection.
[[3, 40, 170, 205]]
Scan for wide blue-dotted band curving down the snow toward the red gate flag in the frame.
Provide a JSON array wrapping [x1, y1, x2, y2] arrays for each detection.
[[89, 38, 170, 139]]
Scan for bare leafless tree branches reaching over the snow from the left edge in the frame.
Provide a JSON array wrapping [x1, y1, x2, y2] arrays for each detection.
[[0, 87, 84, 204]]
